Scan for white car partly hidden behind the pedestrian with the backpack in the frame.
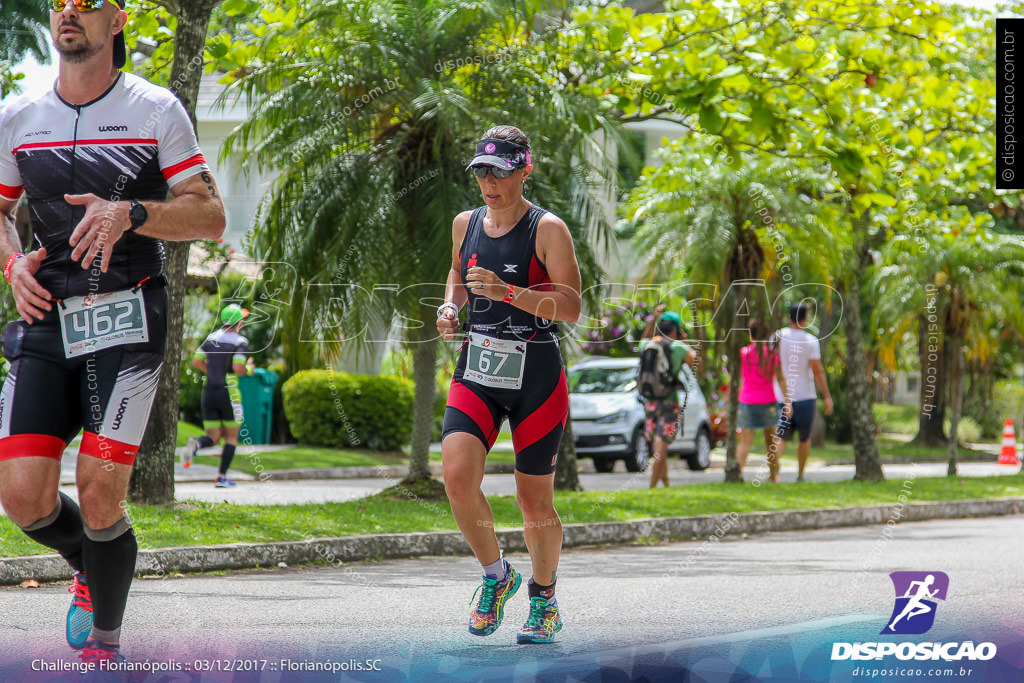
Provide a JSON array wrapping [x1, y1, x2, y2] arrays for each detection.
[[568, 356, 713, 472]]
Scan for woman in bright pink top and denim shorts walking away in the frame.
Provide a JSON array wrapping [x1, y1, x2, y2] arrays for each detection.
[[736, 323, 793, 481]]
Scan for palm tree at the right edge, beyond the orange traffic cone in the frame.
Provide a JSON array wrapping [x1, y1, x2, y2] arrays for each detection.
[[872, 216, 1024, 476]]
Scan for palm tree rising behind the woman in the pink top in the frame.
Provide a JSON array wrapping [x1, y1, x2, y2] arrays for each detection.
[[628, 150, 831, 481]]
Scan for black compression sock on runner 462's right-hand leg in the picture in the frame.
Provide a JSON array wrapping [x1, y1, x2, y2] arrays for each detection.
[[82, 519, 138, 640]]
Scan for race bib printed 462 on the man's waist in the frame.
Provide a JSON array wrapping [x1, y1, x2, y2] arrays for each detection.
[[59, 290, 150, 358]]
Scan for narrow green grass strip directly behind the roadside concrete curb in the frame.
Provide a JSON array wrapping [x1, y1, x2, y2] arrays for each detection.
[[0, 476, 1024, 557]]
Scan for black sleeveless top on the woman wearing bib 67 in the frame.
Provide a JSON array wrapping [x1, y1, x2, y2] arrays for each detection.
[[459, 204, 558, 342]]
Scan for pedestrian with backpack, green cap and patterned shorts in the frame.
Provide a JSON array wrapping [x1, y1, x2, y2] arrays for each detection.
[[637, 306, 696, 488]]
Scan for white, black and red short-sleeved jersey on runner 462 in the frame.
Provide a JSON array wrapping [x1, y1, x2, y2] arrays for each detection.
[[0, 74, 209, 299]]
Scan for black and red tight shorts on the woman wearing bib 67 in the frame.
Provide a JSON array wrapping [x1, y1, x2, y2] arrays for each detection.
[[441, 342, 569, 474]]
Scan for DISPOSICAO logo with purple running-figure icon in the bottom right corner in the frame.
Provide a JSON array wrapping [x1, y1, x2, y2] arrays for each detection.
[[831, 571, 995, 661]]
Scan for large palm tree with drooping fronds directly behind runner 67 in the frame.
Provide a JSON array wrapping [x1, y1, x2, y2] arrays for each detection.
[[225, 0, 617, 479]]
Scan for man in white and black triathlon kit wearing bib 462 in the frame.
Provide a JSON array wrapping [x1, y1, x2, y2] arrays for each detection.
[[0, 0, 224, 663]]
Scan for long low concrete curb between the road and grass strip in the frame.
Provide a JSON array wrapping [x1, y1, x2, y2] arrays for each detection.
[[0, 498, 1024, 586]]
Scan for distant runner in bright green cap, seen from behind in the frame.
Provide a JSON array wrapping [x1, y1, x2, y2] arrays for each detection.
[[187, 303, 253, 488]]
